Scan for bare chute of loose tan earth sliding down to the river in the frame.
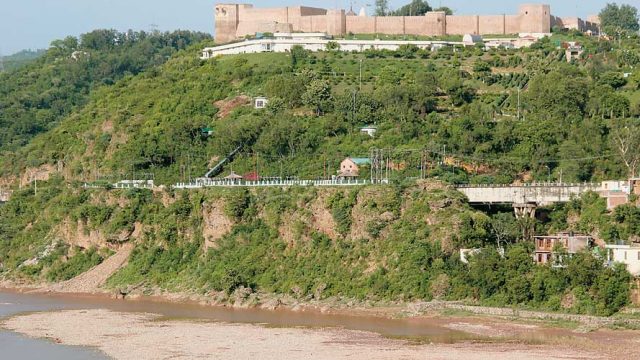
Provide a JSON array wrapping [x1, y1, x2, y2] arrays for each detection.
[[48, 244, 133, 293]]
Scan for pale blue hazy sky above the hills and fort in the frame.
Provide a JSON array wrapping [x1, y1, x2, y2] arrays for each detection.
[[0, 0, 640, 55]]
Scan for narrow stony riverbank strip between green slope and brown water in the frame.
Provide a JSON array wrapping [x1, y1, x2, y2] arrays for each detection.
[[0, 280, 640, 331]]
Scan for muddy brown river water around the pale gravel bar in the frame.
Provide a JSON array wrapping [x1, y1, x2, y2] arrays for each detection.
[[0, 290, 472, 360]]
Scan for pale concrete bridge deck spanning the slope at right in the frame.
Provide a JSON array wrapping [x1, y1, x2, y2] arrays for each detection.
[[456, 183, 601, 206]]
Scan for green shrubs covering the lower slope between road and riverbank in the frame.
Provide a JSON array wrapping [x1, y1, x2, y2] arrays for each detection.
[[0, 181, 640, 315]]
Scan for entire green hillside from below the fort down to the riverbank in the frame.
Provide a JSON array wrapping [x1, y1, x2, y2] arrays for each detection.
[[0, 27, 640, 315]]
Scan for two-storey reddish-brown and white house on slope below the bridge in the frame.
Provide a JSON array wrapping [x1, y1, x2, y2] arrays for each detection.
[[533, 232, 594, 264]]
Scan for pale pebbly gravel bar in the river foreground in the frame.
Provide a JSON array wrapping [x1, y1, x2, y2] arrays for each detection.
[[3, 309, 607, 360]]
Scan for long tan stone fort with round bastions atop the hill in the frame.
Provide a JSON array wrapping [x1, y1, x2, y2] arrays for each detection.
[[215, 4, 599, 44]]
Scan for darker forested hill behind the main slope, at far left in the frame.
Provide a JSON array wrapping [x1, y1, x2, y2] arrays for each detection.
[[0, 30, 208, 151]]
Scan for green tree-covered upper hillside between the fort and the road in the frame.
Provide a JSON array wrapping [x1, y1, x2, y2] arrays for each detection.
[[2, 31, 639, 184]]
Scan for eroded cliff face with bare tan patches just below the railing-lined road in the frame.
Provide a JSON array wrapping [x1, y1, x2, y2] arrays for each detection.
[[0, 183, 474, 289]]
